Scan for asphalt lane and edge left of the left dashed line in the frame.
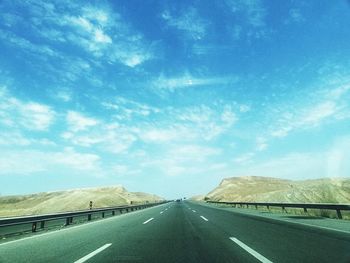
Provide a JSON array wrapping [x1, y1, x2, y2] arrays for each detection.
[[0, 204, 166, 263]]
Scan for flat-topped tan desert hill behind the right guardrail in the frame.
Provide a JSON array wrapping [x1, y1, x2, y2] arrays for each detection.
[[205, 176, 350, 203]]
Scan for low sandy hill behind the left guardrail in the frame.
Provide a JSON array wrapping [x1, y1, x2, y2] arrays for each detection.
[[0, 186, 163, 217]]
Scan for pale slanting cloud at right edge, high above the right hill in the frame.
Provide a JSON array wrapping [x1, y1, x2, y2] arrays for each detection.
[[258, 79, 350, 140]]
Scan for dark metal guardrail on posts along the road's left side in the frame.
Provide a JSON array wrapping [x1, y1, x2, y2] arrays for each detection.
[[0, 201, 167, 232]]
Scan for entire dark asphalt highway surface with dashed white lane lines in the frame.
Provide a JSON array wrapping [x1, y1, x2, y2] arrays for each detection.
[[0, 201, 350, 263]]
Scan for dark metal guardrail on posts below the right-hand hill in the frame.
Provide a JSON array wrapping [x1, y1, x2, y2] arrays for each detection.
[[206, 200, 350, 219]]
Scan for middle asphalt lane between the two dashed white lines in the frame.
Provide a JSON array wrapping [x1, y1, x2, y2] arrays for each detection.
[[93, 202, 259, 263]]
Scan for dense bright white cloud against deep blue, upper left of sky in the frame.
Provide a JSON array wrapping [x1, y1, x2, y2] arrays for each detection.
[[59, 3, 153, 67]]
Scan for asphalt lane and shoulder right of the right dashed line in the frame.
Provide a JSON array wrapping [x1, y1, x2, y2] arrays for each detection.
[[189, 202, 350, 263]]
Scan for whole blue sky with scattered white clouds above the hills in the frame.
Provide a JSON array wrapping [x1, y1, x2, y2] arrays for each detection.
[[0, 0, 350, 198]]
